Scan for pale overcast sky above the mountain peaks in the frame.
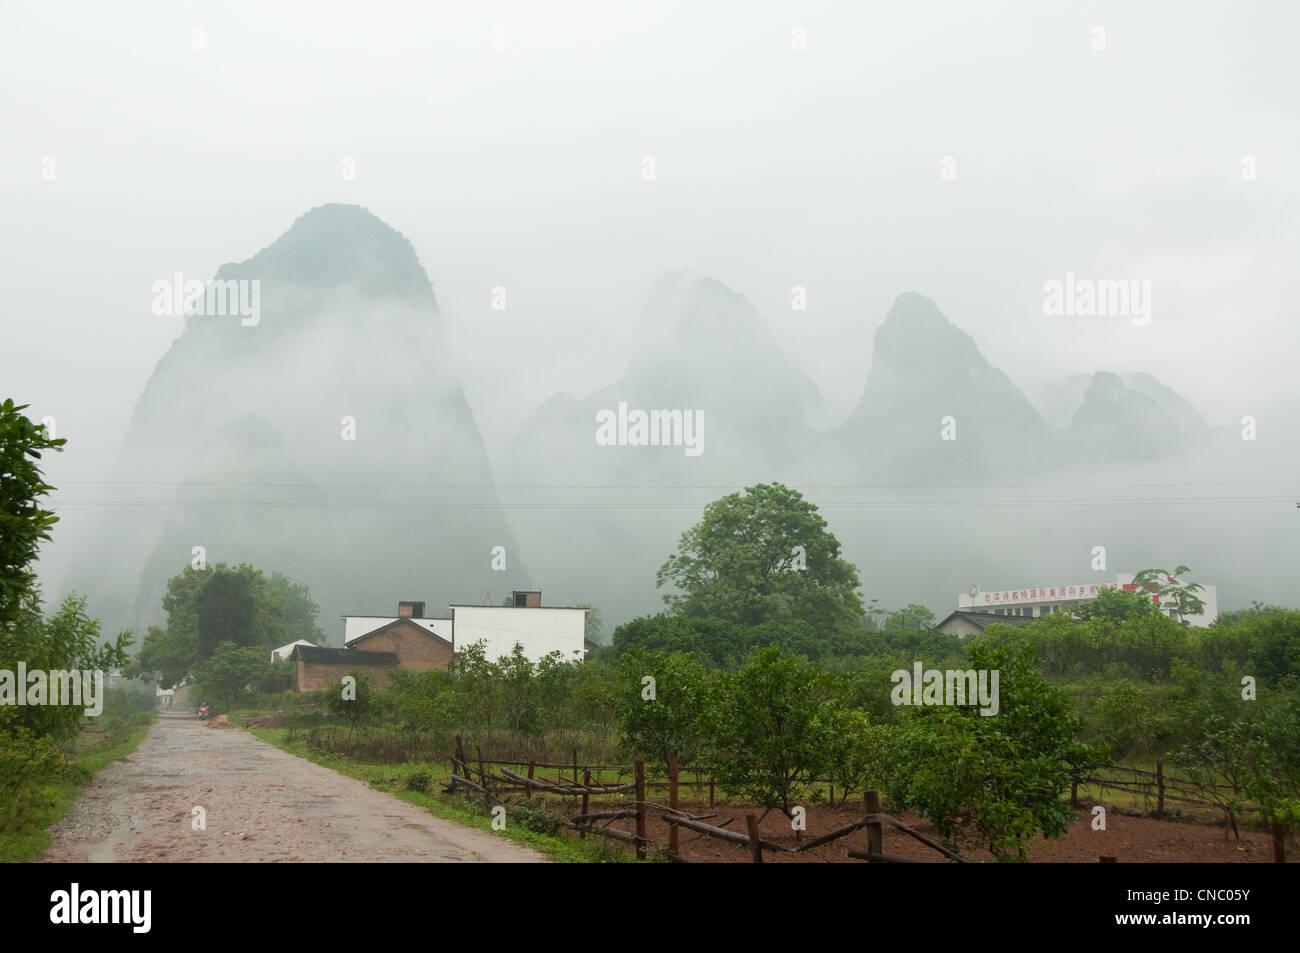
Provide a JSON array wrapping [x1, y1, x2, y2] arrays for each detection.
[[0, 0, 1300, 478]]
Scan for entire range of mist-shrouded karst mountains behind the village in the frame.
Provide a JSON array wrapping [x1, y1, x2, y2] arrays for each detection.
[[53, 205, 1279, 640]]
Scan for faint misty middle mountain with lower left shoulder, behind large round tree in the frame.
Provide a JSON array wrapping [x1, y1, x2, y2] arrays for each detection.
[[502, 273, 824, 619]]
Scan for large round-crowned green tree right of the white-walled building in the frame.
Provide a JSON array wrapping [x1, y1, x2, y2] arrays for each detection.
[[658, 484, 863, 632]]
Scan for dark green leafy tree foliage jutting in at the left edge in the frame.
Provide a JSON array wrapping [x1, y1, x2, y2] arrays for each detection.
[[0, 399, 68, 634]]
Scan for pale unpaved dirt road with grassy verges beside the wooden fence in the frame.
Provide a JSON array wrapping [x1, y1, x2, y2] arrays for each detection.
[[42, 712, 545, 863]]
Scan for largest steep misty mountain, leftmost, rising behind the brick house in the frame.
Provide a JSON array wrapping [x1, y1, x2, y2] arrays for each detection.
[[68, 205, 528, 641]]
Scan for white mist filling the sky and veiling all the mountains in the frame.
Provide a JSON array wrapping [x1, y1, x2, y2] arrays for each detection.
[[0, 3, 1300, 641]]
